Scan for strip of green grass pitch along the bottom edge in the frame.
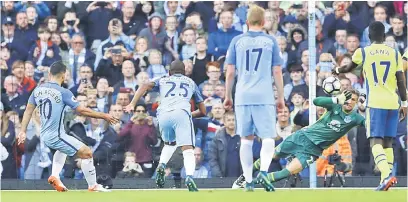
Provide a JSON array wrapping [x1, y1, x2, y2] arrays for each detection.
[[1, 189, 408, 202]]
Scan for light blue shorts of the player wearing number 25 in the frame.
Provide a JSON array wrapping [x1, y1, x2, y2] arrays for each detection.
[[157, 109, 195, 146]]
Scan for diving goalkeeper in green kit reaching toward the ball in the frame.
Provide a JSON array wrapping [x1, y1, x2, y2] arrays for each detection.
[[233, 90, 365, 188]]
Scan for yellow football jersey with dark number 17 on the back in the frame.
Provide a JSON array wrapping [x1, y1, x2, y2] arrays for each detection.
[[352, 44, 403, 109]]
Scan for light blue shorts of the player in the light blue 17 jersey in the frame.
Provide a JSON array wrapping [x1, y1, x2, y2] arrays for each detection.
[[235, 105, 276, 138]]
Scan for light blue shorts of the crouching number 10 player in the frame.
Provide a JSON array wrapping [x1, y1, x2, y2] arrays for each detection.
[[44, 134, 85, 156]]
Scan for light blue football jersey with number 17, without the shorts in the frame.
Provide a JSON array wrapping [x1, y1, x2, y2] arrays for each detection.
[[226, 31, 283, 105]]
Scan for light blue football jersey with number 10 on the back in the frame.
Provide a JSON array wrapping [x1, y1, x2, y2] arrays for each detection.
[[28, 82, 79, 141]]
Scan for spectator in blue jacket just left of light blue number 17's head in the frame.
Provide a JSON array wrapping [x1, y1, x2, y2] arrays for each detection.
[[208, 10, 242, 59]]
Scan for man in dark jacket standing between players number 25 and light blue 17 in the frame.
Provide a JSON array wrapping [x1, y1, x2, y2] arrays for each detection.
[[209, 112, 242, 177]]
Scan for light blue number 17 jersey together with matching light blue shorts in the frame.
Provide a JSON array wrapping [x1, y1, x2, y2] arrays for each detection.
[[226, 31, 282, 138]]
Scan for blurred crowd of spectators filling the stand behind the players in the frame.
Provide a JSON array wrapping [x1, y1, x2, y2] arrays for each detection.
[[0, 1, 408, 183]]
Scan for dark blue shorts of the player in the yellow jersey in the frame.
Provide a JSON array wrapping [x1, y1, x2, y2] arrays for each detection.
[[366, 108, 398, 138]]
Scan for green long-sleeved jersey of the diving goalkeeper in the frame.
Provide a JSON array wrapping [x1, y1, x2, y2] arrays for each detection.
[[302, 97, 365, 149]]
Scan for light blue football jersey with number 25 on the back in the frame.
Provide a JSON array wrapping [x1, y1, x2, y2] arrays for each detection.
[[154, 74, 203, 114]]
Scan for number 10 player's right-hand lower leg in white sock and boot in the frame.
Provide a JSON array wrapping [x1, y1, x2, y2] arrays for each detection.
[[77, 145, 110, 192]]
